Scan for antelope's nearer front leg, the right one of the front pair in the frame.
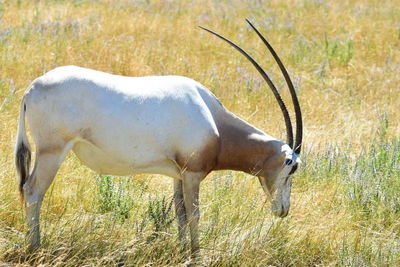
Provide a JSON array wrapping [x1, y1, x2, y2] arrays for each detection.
[[183, 172, 204, 256]]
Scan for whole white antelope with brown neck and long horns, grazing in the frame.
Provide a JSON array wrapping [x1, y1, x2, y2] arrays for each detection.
[[15, 21, 302, 253]]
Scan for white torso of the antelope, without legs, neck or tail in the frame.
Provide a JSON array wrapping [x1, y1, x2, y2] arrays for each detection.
[[25, 66, 225, 178]]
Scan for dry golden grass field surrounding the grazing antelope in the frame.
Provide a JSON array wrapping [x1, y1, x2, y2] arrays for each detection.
[[0, 0, 400, 266]]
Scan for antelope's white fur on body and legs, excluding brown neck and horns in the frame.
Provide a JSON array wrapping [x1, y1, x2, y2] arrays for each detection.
[[16, 66, 297, 252]]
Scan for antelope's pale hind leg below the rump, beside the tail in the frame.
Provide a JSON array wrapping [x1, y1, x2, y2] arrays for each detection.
[[23, 146, 70, 250]]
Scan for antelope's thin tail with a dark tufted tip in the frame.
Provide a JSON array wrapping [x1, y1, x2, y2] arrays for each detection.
[[15, 97, 31, 200]]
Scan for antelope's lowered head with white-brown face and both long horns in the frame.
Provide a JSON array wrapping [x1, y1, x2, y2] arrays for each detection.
[[201, 19, 303, 220]]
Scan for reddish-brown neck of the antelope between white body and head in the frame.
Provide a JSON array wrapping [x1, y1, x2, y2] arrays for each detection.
[[214, 113, 282, 175]]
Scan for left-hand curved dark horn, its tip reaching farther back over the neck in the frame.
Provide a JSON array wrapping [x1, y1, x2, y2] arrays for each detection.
[[199, 26, 293, 147]]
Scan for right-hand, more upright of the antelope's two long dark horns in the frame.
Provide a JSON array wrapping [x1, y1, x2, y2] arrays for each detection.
[[246, 19, 303, 154]]
